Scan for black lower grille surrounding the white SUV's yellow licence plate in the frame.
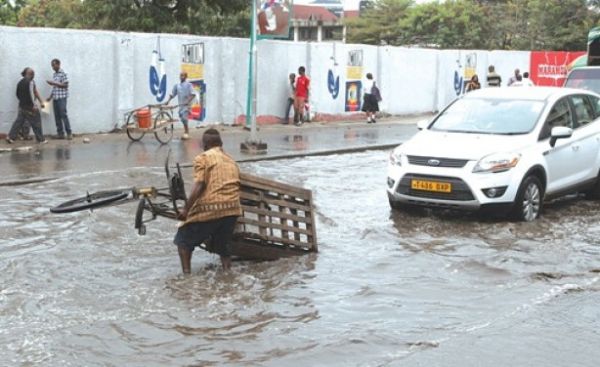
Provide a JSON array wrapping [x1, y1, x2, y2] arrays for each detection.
[[396, 174, 475, 201]]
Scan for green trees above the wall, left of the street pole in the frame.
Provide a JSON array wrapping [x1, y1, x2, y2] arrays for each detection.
[[6, 0, 250, 37]]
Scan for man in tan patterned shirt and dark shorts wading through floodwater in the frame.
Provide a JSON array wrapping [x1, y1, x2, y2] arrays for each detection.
[[174, 129, 242, 274]]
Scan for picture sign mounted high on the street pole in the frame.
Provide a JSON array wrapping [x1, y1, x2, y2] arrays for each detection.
[[256, 0, 293, 38]]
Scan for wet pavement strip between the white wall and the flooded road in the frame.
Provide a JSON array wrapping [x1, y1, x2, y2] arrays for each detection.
[[0, 114, 431, 186]]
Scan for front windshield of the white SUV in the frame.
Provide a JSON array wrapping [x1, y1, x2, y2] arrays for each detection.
[[430, 98, 544, 135]]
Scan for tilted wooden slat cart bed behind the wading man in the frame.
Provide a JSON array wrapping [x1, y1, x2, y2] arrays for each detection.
[[226, 173, 318, 260]]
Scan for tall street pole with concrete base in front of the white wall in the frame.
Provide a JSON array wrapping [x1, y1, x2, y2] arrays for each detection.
[[240, 0, 267, 154]]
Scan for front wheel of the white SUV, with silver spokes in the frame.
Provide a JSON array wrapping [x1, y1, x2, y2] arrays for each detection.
[[512, 176, 544, 222]]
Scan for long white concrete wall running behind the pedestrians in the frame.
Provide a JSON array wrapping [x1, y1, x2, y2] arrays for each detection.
[[0, 27, 530, 134]]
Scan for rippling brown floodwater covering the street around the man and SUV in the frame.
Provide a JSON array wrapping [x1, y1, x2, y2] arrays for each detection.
[[0, 152, 600, 366]]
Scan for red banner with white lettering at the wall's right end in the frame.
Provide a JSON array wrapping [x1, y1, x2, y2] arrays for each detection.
[[529, 51, 585, 87]]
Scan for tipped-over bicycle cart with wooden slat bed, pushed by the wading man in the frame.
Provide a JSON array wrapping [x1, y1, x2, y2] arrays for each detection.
[[50, 164, 318, 260]]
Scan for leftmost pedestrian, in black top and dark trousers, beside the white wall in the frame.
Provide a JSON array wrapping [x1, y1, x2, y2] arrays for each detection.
[[6, 68, 47, 144]]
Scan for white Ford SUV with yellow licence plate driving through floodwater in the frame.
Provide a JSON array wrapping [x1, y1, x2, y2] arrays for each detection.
[[387, 87, 600, 221]]
